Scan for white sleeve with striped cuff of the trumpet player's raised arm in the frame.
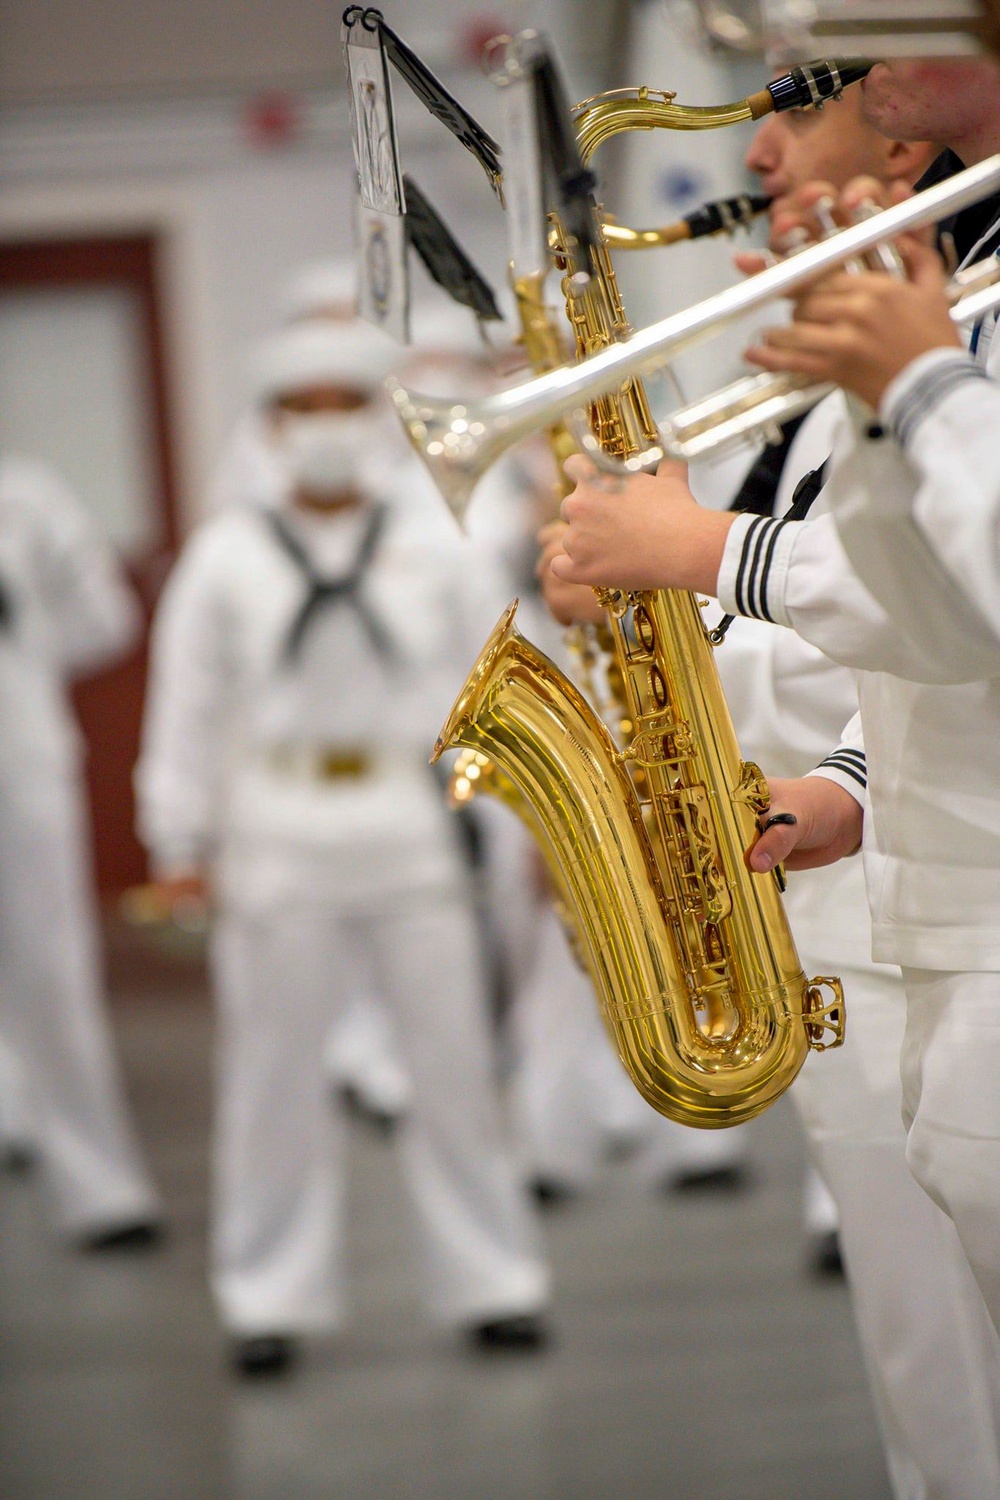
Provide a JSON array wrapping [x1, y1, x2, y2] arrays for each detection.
[[828, 350, 1000, 680]]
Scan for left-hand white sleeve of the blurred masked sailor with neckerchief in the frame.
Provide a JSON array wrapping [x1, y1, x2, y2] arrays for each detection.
[[135, 533, 235, 873]]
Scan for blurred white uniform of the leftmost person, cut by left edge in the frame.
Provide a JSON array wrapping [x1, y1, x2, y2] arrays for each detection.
[[0, 455, 160, 1239]]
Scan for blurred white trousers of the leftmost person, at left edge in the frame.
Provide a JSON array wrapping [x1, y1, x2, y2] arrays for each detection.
[[0, 782, 160, 1236]]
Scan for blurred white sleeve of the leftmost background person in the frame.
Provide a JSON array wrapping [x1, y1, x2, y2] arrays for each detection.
[[31, 465, 142, 677]]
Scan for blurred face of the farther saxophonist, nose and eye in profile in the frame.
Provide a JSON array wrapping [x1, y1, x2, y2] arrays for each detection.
[[747, 89, 889, 198]]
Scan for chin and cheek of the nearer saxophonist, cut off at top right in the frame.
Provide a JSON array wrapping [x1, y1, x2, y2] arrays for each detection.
[[861, 57, 1000, 144]]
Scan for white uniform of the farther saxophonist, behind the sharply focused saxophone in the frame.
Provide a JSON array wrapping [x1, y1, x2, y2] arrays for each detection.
[[717, 396, 1000, 1500]]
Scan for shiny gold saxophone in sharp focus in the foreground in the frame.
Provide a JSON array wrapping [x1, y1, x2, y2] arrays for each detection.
[[432, 61, 844, 1130]]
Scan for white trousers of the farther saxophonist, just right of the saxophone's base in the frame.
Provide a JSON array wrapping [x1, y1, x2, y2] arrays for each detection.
[[792, 965, 1000, 1500]]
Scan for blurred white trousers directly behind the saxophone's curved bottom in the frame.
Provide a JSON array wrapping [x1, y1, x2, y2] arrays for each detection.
[[514, 908, 745, 1187]]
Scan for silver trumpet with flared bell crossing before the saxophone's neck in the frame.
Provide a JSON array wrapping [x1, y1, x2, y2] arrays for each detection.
[[387, 155, 1000, 521]]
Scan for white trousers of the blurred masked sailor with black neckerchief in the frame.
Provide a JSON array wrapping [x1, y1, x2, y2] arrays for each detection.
[[211, 890, 549, 1334]]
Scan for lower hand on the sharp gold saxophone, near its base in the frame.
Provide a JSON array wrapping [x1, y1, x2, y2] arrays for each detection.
[[747, 776, 864, 875]]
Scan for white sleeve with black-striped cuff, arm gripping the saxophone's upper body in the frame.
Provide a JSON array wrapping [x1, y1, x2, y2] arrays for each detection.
[[718, 507, 1000, 683]]
